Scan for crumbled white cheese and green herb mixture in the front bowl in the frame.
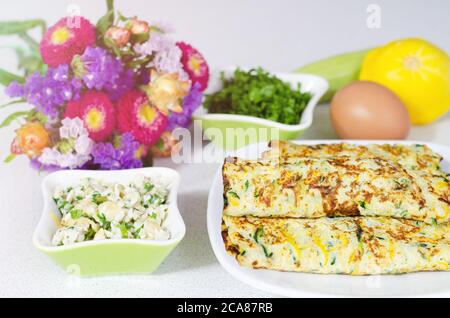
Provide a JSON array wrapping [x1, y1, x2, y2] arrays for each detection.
[[52, 176, 170, 246]]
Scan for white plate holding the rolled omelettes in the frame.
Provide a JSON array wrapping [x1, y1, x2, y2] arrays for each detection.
[[207, 140, 450, 297]]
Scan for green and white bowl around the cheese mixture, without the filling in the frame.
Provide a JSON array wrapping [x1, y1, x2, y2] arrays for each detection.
[[33, 168, 186, 276]]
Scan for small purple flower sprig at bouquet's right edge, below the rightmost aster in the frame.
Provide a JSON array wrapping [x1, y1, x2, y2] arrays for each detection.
[[167, 83, 203, 130]]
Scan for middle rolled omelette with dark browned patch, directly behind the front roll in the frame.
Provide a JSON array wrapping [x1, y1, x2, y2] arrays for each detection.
[[222, 157, 450, 224]]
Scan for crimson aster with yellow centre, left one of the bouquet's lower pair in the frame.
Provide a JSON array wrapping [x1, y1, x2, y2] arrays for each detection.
[[64, 91, 115, 142]]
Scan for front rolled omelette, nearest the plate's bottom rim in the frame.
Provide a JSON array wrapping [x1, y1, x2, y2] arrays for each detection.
[[222, 216, 450, 275]]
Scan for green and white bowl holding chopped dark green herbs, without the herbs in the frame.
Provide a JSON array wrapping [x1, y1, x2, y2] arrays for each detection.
[[193, 67, 328, 150]]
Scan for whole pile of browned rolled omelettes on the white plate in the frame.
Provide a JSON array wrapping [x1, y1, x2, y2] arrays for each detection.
[[222, 141, 450, 275]]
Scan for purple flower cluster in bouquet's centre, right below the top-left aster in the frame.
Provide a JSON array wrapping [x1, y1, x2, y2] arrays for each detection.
[[72, 47, 134, 101]]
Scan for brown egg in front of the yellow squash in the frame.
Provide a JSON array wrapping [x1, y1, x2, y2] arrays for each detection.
[[331, 81, 410, 139]]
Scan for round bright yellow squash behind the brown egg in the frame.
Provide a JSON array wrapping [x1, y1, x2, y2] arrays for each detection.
[[359, 39, 450, 125]]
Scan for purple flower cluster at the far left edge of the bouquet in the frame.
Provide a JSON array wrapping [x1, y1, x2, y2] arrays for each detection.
[[5, 64, 81, 118]]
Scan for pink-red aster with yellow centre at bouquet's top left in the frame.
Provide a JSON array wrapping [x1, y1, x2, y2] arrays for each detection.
[[40, 16, 96, 67]]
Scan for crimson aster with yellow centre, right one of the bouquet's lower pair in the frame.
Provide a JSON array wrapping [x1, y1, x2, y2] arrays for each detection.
[[116, 90, 168, 145]]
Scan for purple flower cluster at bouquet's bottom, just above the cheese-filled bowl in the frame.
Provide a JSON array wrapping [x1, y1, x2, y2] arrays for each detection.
[[92, 133, 142, 170]]
